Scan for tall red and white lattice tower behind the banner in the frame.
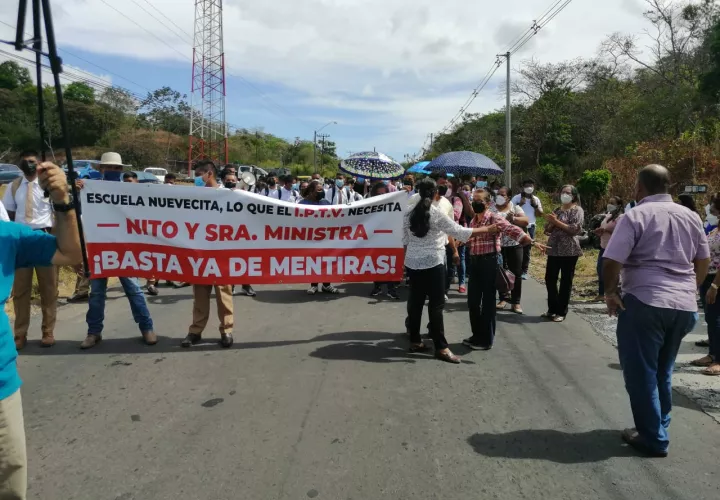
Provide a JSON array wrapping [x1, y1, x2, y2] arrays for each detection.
[[188, 0, 228, 175]]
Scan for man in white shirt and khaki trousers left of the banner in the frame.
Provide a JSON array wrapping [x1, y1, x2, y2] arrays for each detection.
[[2, 151, 58, 350]]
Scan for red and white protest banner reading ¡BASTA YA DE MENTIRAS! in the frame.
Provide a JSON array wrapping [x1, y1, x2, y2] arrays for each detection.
[[80, 181, 407, 285]]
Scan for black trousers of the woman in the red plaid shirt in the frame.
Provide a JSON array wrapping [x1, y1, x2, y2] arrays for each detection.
[[468, 253, 498, 347]]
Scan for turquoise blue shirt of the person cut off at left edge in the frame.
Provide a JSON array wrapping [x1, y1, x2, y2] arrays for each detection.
[[0, 221, 57, 400]]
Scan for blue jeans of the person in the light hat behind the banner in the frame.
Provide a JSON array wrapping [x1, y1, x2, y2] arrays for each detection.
[[85, 278, 153, 335]]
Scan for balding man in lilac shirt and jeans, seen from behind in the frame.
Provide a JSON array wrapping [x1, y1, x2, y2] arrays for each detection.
[[603, 165, 710, 457]]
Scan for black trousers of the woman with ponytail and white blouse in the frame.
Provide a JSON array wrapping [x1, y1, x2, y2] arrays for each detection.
[[405, 264, 448, 351]]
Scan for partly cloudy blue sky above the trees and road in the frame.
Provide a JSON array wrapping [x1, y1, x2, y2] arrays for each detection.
[[0, 0, 648, 161]]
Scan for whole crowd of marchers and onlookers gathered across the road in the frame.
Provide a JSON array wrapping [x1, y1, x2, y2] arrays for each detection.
[[0, 151, 720, 498]]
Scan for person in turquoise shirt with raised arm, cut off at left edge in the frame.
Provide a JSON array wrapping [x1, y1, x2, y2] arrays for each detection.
[[0, 163, 82, 499]]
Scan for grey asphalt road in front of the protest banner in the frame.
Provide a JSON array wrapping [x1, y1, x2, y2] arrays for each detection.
[[19, 282, 720, 500]]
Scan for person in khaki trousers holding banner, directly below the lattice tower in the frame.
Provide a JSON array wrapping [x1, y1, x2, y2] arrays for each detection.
[[180, 160, 234, 348]]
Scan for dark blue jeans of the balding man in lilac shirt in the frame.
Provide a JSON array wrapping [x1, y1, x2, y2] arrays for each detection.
[[617, 294, 698, 452]]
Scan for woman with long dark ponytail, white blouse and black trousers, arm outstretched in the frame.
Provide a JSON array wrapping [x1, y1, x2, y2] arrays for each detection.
[[403, 178, 497, 364]]
